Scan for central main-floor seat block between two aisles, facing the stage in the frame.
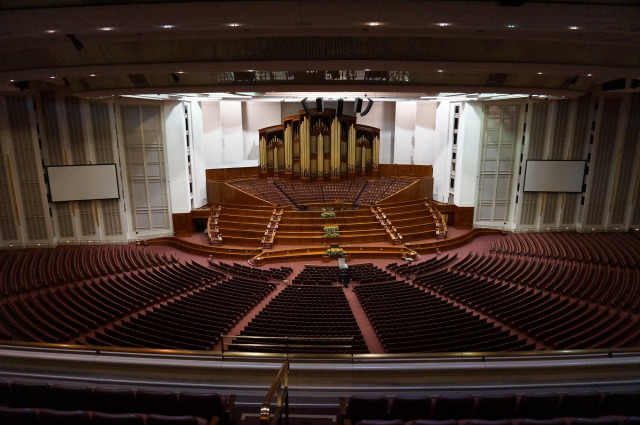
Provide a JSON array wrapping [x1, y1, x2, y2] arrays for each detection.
[[230, 285, 367, 353]]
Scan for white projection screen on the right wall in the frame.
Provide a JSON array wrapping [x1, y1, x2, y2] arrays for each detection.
[[524, 160, 586, 193]]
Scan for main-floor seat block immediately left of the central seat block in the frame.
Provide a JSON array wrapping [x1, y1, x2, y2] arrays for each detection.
[[86, 278, 276, 350]]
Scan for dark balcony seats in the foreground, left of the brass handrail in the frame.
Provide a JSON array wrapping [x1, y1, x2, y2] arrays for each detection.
[[0, 381, 235, 425]]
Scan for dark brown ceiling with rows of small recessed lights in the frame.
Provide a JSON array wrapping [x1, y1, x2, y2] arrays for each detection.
[[0, 0, 640, 98]]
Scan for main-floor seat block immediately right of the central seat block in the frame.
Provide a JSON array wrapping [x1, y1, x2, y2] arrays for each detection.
[[354, 282, 533, 353]]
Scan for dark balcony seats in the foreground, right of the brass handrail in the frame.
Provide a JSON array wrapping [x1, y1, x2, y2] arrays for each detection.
[[339, 389, 640, 425]]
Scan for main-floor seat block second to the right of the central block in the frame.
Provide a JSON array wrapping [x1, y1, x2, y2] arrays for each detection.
[[414, 270, 640, 349]]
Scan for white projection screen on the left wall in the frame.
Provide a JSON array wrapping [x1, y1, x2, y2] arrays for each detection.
[[47, 164, 120, 202]]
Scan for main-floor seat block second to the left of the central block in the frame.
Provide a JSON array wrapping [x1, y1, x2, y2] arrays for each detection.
[[0, 263, 221, 342]]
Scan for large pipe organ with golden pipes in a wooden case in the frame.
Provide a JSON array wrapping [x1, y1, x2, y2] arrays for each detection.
[[259, 108, 380, 179]]
